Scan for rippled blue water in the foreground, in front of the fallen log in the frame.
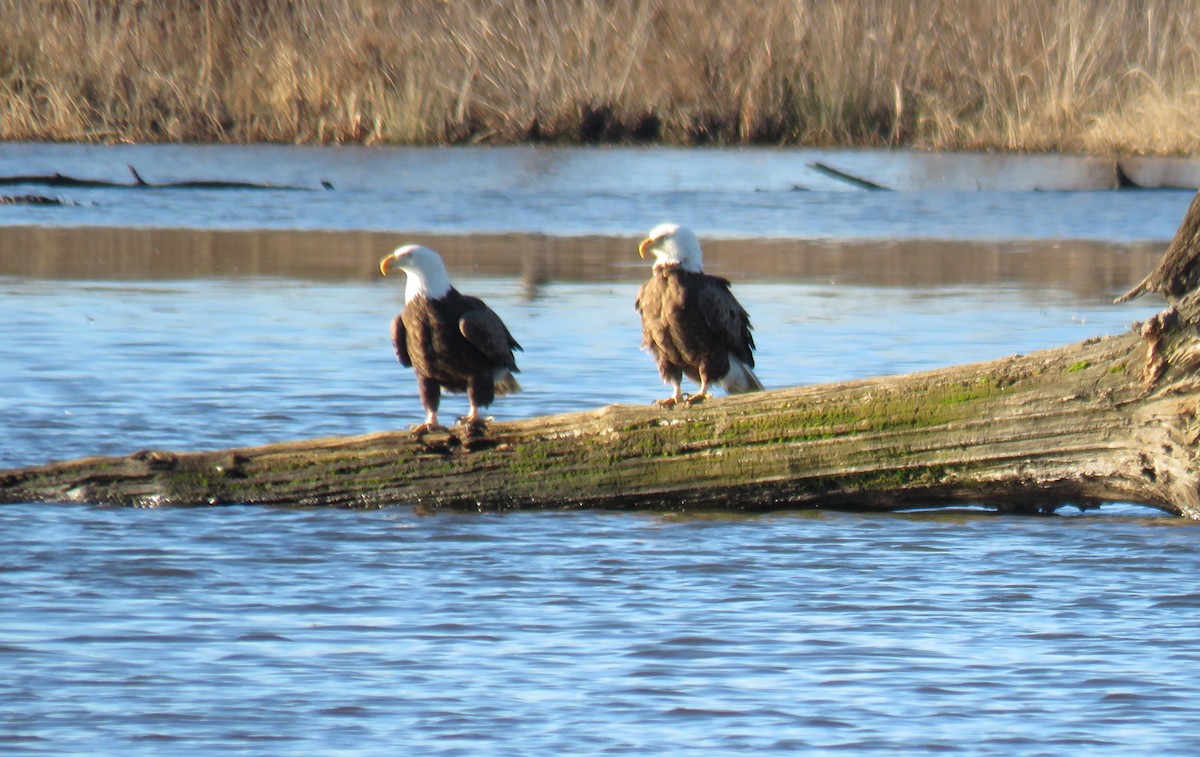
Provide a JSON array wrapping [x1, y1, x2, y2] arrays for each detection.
[[0, 506, 1200, 755]]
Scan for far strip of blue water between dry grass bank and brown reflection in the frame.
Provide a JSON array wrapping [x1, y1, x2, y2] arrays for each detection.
[[0, 144, 1194, 242]]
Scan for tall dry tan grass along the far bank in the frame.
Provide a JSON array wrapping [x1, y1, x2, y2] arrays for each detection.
[[0, 0, 1200, 154]]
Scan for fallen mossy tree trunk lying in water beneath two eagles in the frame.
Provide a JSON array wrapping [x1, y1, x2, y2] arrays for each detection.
[[7, 195, 1200, 518]]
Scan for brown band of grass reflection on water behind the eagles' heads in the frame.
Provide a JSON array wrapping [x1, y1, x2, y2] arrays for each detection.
[[0, 227, 1165, 300]]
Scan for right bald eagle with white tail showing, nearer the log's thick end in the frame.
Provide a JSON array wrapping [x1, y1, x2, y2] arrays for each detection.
[[636, 223, 762, 407]]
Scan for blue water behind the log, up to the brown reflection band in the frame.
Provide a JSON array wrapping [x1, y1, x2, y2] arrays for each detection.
[[0, 277, 1157, 468]]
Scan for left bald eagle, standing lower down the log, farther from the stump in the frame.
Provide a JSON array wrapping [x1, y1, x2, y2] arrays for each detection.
[[379, 245, 521, 433]]
